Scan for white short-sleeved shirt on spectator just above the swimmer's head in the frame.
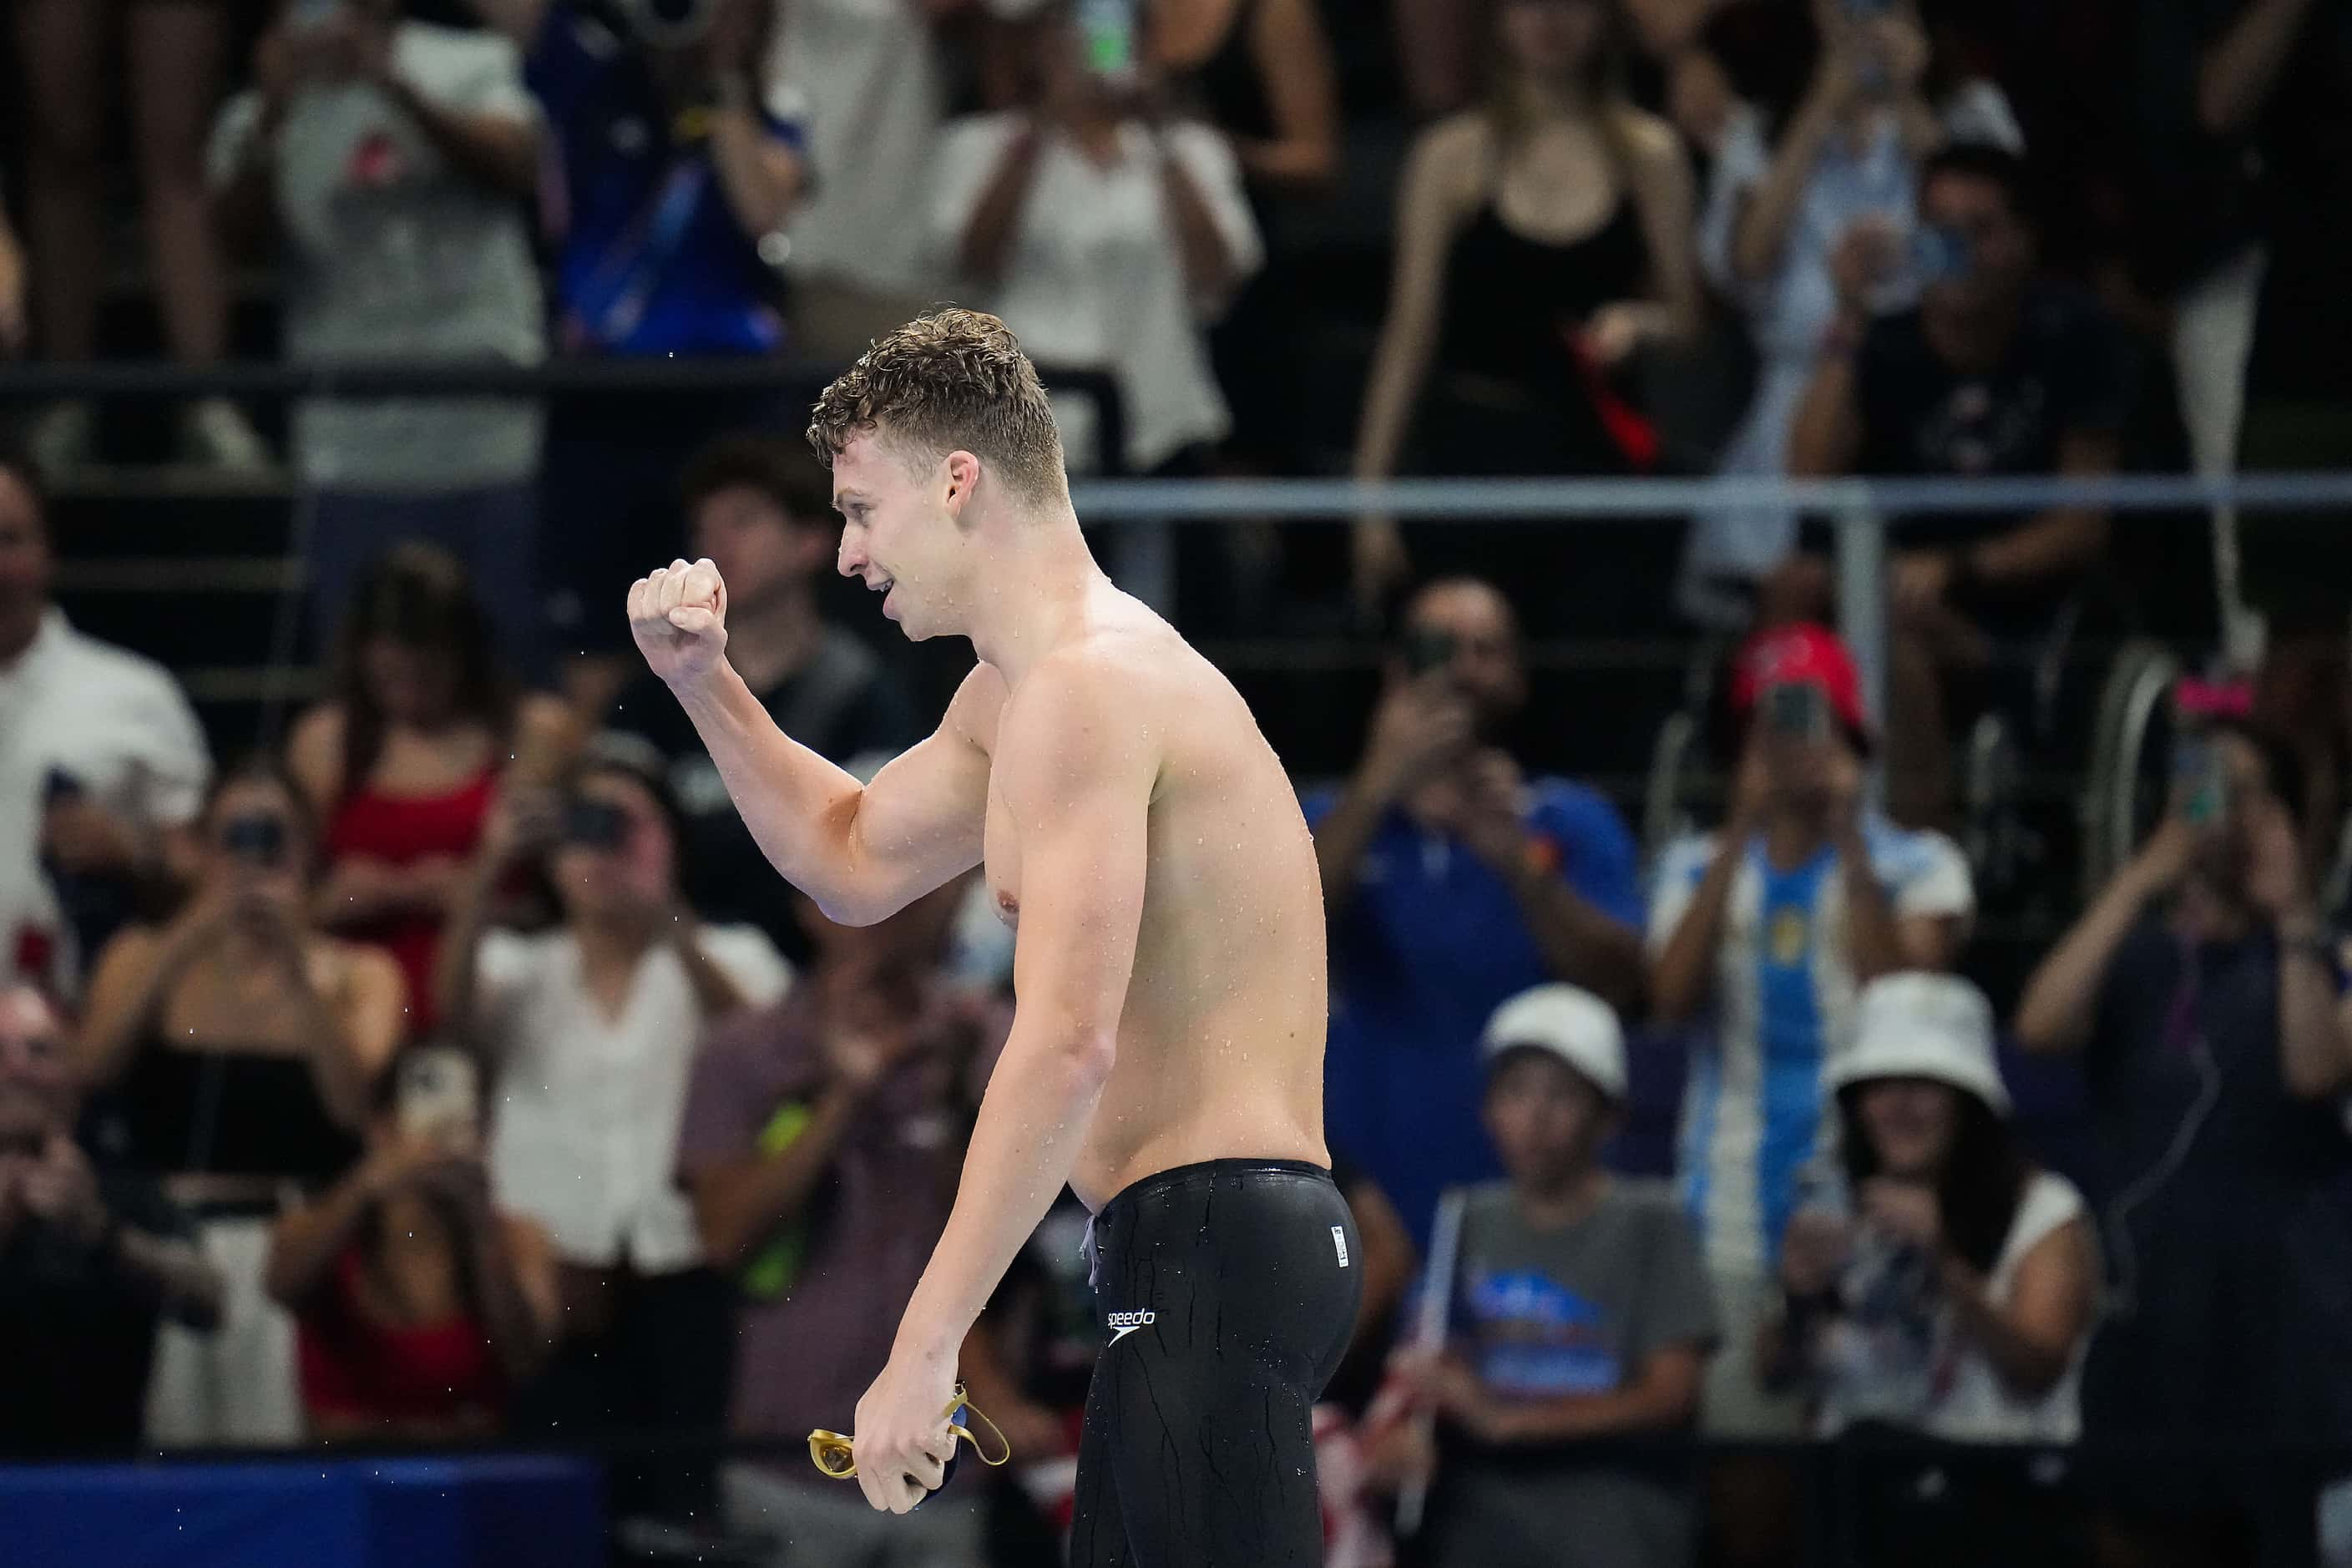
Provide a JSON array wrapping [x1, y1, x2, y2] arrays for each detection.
[[932, 113, 1266, 473]]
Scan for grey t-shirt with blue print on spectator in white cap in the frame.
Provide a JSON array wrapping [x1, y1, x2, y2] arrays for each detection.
[[1433, 1178, 1717, 1568]]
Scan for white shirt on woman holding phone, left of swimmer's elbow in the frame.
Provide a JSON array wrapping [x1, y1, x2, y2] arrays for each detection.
[[475, 926, 792, 1274]]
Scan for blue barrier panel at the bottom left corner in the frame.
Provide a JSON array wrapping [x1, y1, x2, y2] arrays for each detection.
[[0, 1455, 604, 1568]]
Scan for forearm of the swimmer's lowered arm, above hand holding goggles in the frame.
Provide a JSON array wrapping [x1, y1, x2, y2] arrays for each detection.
[[892, 1018, 1110, 1361]]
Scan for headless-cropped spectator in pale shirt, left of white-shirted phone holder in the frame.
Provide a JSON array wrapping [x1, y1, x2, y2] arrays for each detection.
[[766, 0, 959, 364]]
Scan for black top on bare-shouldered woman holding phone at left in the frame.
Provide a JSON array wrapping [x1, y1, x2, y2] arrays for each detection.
[[115, 1037, 360, 1185]]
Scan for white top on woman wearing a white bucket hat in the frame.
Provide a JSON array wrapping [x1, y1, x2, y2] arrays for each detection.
[[1820, 1171, 2091, 1444]]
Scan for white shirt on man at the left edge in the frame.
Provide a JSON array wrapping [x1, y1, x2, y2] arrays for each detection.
[[0, 609, 212, 989]]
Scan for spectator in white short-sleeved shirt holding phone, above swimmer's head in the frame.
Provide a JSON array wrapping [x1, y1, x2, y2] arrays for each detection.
[[932, 0, 1263, 473]]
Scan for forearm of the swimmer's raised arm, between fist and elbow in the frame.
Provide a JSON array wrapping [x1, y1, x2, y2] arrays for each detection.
[[673, 663, 866, 914]]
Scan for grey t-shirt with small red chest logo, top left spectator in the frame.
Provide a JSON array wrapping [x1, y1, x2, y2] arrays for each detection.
[[210, 21, 546, 493]]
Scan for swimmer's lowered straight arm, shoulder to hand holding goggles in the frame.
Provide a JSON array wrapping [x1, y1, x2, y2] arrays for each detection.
[[856, 660, 1160, 1511]]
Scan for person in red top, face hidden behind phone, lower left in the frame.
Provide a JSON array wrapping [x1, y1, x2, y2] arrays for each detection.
[[266, 1046, 562, 1444]]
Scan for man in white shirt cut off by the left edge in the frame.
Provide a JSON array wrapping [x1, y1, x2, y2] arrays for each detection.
[[0, 452, 212, 994]]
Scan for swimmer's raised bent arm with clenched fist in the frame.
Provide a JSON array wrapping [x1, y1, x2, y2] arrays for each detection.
[[628, 559, 983, 926]]
